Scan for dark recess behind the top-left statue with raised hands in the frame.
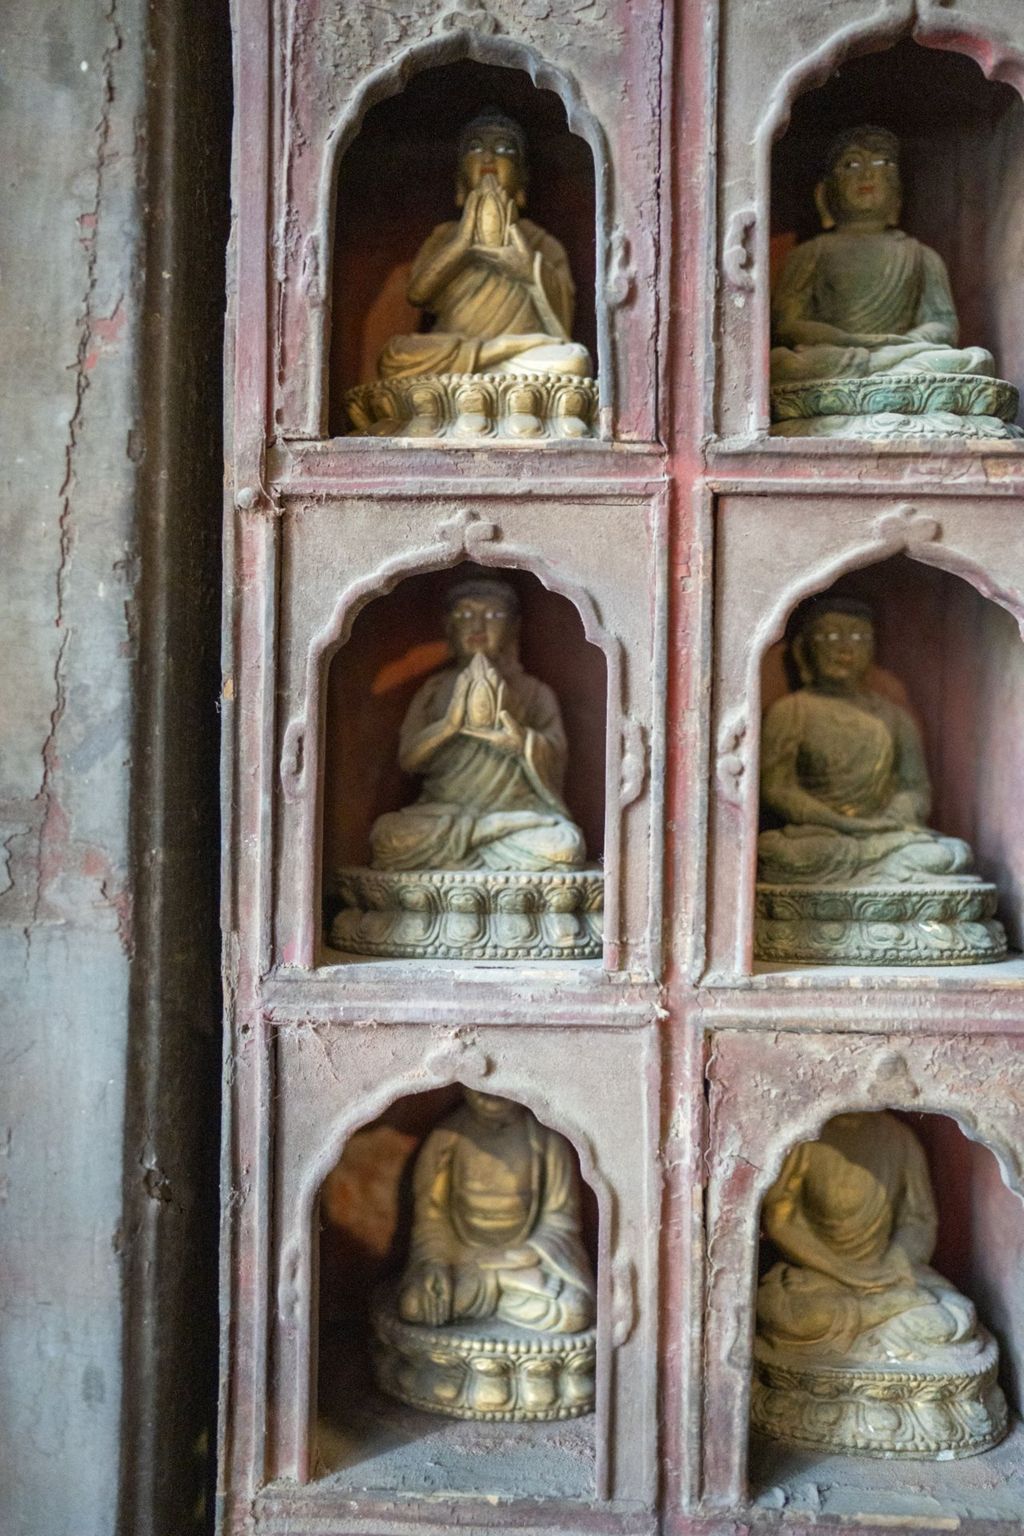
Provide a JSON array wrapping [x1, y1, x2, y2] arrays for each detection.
[[329, 58, 605, 436]]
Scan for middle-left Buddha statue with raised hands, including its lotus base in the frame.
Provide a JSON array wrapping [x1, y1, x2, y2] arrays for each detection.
[[333, 576, 600, 957]]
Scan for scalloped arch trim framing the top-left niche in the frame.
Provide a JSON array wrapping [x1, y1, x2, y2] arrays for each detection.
[[302, 26, 607, 436]]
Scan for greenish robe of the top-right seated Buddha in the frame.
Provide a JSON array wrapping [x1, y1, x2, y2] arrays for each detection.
[[771, 229, 995, 384]]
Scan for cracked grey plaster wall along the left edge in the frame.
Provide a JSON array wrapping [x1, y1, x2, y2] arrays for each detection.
[[0, 0, 146, 1536]]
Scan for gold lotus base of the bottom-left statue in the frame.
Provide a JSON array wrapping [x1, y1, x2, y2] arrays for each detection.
[[370, 1284, 597, 1422]]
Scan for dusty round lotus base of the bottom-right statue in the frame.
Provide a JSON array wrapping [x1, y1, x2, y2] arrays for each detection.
[[751, 1330, 1007, 1461]]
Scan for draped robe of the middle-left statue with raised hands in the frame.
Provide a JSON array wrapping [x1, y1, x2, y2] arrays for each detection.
[[370, 664, 586, 869]]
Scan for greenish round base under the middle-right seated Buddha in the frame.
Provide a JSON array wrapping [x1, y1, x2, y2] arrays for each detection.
[[754, 880, 1006, 965]]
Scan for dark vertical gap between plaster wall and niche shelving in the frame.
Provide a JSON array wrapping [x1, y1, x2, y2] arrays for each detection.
[[118, 0, 232, 1536]]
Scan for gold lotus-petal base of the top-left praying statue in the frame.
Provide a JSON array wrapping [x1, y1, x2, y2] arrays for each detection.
[[345, 373, 597, 442]]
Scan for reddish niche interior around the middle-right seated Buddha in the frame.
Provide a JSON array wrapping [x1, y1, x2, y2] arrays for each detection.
[[760, 550, 1024, 949]]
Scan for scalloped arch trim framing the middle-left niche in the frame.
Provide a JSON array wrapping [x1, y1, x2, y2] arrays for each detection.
[[281, 511, 629, 969]]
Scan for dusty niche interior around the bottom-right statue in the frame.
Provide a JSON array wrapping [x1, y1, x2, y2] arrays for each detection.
[[748, 1107, 1024, 1519]]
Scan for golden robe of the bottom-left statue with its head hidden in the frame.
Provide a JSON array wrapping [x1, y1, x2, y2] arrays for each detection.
[[399, 1106, 594, 1333]]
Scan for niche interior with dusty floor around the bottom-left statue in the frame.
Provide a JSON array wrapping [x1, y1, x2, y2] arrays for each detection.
[[310, 1083, 606, 1499]]
